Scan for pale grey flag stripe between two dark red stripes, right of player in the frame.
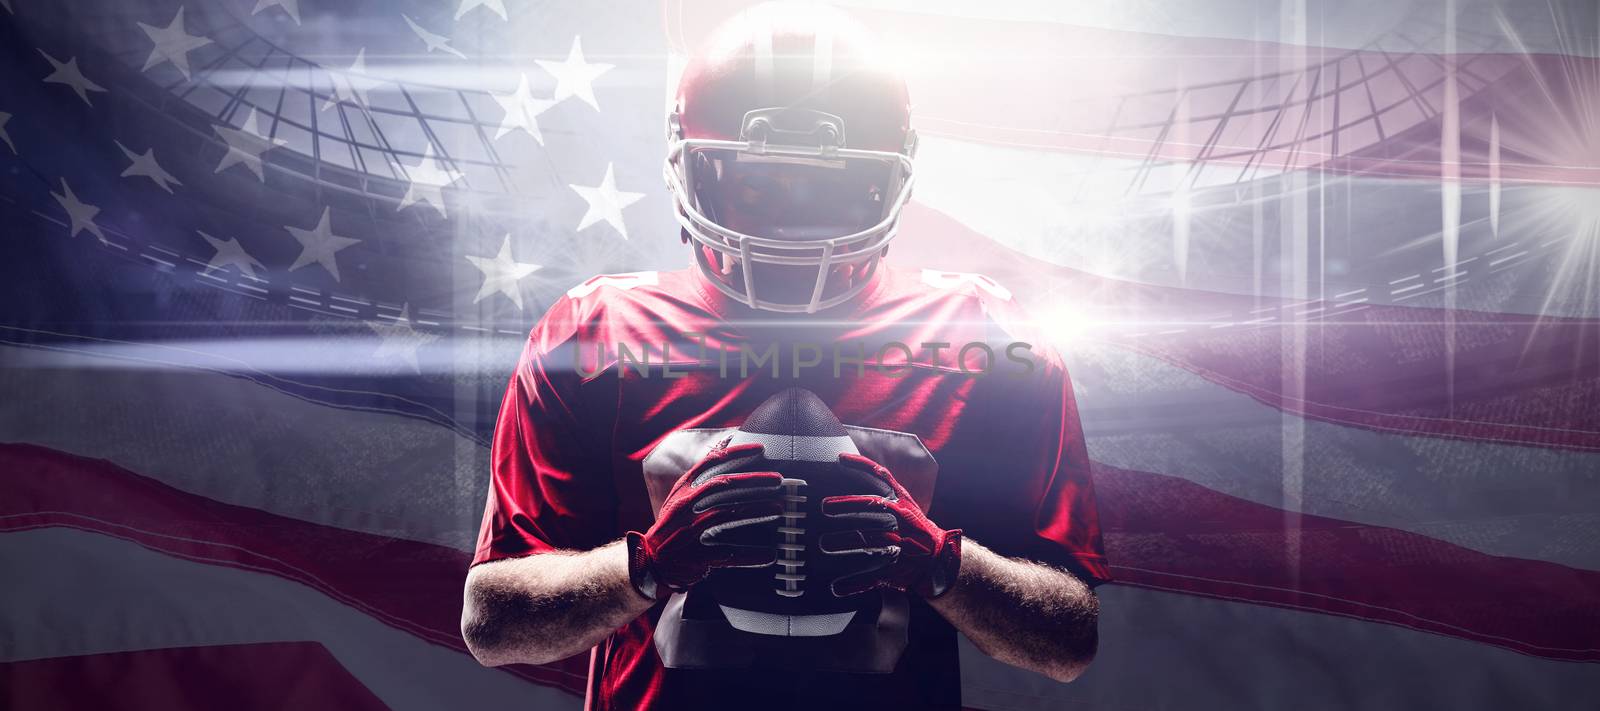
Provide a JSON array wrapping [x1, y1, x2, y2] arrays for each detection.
[[1066, 343, 1600, 570]]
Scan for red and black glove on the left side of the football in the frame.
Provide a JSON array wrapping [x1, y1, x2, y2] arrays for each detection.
[[627, 440, 784, 599]]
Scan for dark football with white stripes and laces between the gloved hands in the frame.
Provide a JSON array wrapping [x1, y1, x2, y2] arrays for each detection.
[[656, 388, 907, 673]]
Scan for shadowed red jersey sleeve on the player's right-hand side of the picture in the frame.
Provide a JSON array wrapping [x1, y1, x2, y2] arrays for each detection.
[[931, 357, 1110, 586]]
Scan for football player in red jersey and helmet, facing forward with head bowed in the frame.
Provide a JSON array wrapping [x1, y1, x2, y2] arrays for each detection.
[[461, 5, 1109, 709]]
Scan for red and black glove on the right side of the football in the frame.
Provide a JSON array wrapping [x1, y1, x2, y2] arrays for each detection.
[[819, 453, 962, 597]]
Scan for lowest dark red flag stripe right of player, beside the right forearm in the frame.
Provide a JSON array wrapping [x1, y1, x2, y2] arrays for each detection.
[[1094, 464, 1600, 661]]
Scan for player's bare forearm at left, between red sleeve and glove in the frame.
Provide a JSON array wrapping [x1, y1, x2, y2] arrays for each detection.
[[461, 541, 651, 666]]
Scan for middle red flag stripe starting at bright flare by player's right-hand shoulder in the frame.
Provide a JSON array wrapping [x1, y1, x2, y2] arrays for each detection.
[[899, 205, 1600, 452]]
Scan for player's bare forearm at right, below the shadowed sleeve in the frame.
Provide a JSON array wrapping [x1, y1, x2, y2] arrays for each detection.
[[930, 538, 1099, 682]]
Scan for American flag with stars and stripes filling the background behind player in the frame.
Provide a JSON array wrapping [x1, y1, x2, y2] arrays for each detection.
[[0, 0, 1600, 709]]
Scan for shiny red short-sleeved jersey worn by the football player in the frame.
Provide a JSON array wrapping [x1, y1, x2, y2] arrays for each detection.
[[474, 267, 1109, 709]]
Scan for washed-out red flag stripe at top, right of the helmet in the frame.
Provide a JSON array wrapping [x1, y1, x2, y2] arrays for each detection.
[[667, 3, 1600, 186]]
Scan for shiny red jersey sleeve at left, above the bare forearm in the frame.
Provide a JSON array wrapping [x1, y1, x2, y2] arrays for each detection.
[[472, 315, 616, 565]]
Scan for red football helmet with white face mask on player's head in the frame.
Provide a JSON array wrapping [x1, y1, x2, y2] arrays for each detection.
[[666, 3, 917, 312]]
